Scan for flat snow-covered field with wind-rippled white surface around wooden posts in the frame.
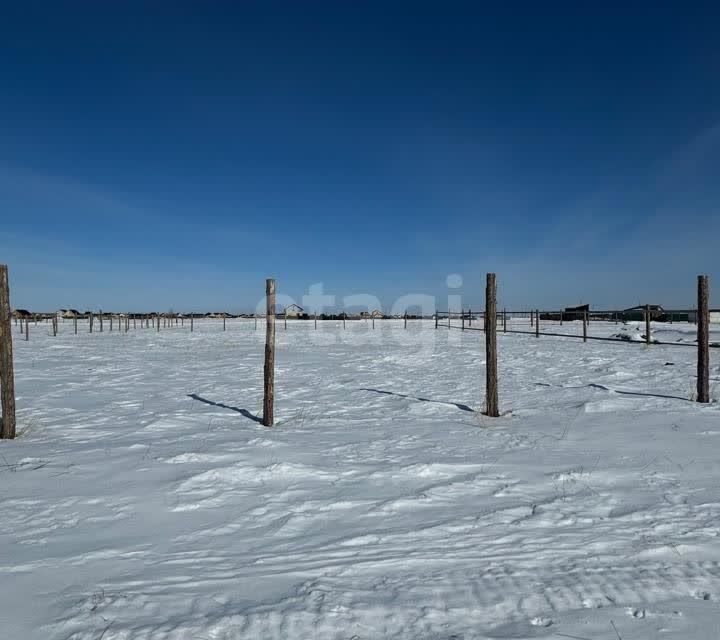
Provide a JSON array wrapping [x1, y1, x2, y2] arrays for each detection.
[[0, 320, 720, 640]]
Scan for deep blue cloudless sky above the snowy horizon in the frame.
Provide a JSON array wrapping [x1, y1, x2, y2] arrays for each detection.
[[0, 0, 720, 311]]
